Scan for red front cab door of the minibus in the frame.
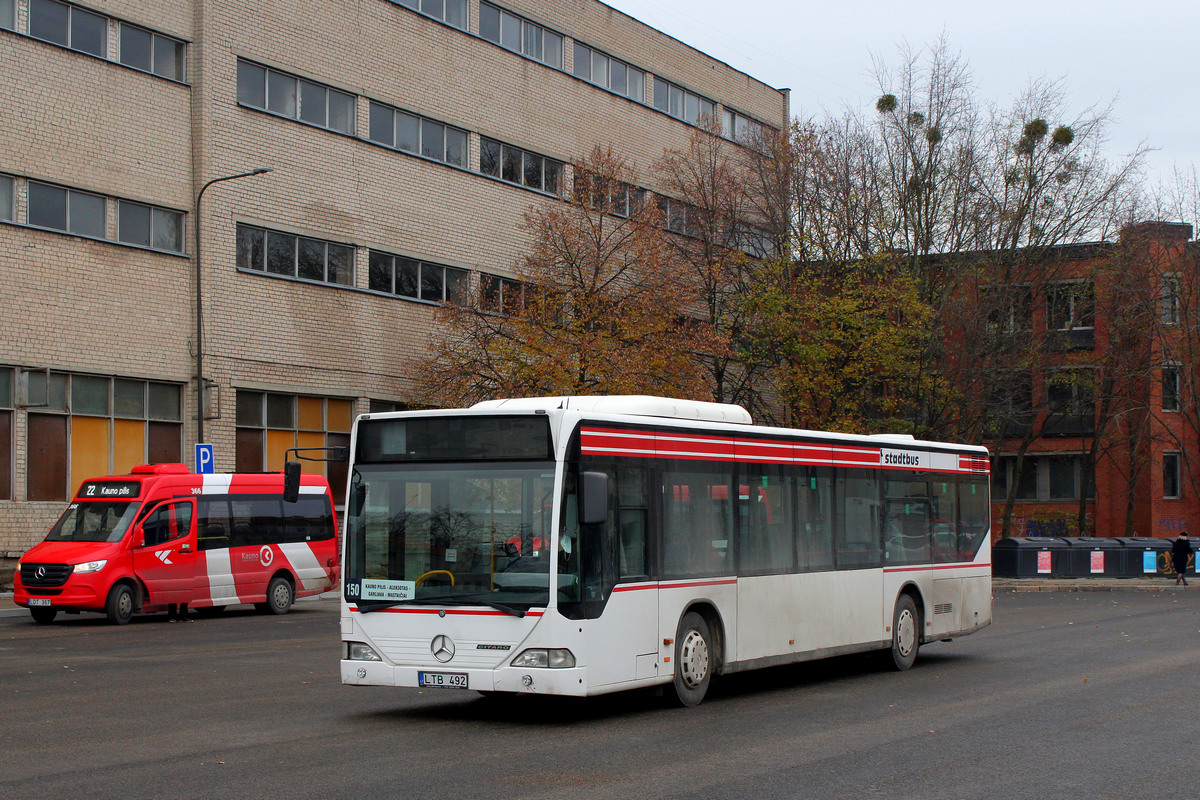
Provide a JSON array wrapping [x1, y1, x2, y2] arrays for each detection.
[[133, 499, 196, 606]]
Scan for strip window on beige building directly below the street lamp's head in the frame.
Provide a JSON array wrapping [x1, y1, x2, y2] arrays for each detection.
[[238, 225, 354, 287]]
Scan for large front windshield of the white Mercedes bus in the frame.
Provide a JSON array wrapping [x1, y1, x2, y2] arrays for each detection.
[[344, 461, 554, 612]]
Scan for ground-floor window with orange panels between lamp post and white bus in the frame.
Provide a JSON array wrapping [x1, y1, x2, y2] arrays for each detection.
[[235, 389, 354, 503]]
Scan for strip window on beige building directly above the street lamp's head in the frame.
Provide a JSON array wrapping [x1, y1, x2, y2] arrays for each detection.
[[238, 61, 355, 134]]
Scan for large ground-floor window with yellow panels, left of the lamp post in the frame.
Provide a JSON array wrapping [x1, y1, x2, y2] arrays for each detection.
[[25, 372, 184, 500]]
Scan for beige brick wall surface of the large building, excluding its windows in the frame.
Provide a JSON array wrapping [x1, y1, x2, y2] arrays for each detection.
[[0, 0, 787, 557]]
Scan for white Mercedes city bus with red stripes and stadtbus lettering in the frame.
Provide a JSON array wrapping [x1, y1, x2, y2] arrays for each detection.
[[341, 397, 991, 705]]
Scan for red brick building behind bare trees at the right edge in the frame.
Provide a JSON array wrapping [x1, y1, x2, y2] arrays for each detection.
[[984, 222, 1200, 537]]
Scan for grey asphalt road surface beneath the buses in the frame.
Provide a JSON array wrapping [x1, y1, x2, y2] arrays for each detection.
[[0, 591, 1200, 800]]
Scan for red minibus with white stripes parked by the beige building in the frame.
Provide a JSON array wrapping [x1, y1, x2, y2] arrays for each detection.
[[13, 464, 340, 625]]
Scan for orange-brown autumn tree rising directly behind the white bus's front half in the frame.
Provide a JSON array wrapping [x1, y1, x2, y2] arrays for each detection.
[[415, 148, 727, 407]]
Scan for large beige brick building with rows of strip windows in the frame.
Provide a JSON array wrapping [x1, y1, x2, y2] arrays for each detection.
[[0, 0, 788, 558]]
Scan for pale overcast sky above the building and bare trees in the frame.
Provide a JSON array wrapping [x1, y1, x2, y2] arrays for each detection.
[[604, 0, 1200, 190]]
